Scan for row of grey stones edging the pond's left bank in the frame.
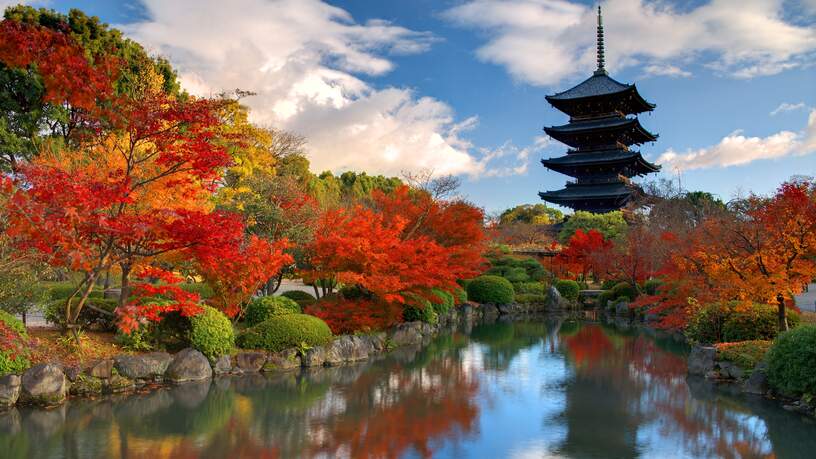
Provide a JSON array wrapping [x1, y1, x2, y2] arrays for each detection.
[[0, 304, 488, 409]]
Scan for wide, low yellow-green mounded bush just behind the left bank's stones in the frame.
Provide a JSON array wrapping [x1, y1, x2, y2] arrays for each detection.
[[237, 314, 332, 352]]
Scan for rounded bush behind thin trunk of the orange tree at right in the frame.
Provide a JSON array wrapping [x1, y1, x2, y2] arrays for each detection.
[[723, 304, 799, 342]]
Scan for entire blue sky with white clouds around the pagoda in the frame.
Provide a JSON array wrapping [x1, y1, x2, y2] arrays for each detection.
[[12, 0, 816, 211]]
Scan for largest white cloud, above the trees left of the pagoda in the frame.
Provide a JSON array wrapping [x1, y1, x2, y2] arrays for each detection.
[[123, 0, 516, 176]]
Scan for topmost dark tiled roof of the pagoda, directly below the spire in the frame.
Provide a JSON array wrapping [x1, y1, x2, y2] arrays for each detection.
[[545, 70, 656, 115]]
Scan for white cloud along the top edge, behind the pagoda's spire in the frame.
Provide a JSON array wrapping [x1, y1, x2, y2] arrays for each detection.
[[444, 0, 816, 85]]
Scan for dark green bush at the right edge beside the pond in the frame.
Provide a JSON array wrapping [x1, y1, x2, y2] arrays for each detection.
[[768, 325, 816, 396]]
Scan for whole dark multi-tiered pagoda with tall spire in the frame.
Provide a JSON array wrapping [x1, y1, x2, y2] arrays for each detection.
[[539, 6, 660, 212]]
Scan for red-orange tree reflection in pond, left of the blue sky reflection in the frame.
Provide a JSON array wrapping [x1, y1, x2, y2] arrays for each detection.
[[314, 359, 479, 458]]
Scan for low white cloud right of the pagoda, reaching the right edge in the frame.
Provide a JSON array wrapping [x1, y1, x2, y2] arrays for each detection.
[[656, 110, 816, 172]]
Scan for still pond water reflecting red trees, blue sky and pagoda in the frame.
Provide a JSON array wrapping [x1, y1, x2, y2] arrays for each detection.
[[0, 319, 816, 459]]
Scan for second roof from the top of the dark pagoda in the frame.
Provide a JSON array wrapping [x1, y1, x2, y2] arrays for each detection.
[[544, 116, 657, 148]]
